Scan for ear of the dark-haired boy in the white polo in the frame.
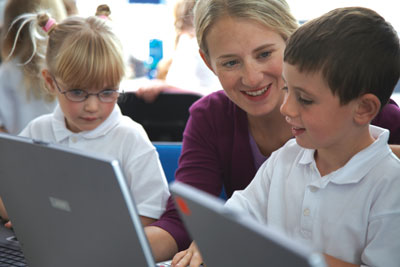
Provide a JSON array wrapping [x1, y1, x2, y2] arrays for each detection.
[[354, 94, 381, 125]]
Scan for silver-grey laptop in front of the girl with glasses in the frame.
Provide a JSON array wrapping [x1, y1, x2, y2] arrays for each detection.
[[0, 134, 170, 267]]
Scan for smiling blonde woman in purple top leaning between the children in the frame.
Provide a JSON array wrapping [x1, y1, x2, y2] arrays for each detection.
[[146, 0, 400, 266]]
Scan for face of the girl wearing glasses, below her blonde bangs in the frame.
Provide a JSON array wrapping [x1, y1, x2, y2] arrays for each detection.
[[43, 72, 118, 133]]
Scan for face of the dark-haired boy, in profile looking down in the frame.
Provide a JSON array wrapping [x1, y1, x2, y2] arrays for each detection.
[[281, 62, 356, 151]]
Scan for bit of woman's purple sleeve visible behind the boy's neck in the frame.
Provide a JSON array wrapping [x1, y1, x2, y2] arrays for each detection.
[[371, 99, 400, 144]]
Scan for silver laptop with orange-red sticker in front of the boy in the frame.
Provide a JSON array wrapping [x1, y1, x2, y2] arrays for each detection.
[[170, 182, 326, 267]]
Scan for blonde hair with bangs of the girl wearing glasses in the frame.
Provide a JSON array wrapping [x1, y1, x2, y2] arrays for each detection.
[[7, 5, 125, 95]]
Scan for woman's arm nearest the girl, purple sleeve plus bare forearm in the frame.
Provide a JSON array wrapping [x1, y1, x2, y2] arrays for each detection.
[[146, 94, 230, 260]]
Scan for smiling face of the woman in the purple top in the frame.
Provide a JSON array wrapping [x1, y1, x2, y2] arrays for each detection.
[[205, 17, 285, 116]]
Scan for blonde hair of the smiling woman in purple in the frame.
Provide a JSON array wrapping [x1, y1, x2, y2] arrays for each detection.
[[194, 0, 298, 56]]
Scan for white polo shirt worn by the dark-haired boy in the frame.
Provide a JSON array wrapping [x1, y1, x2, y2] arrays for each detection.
[[226, 126, 400, 266]]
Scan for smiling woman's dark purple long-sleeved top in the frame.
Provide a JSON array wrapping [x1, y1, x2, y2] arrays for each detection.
[[152, 91, 400, 251]]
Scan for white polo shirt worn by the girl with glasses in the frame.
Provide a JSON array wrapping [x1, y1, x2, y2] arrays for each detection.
[[20, 105, 169, 219]]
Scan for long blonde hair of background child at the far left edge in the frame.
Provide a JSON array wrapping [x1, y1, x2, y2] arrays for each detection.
[[1, 0, 66, 101]]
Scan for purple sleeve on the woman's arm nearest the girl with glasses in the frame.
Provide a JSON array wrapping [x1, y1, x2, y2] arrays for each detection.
[[152, 92, 227, 251]]
